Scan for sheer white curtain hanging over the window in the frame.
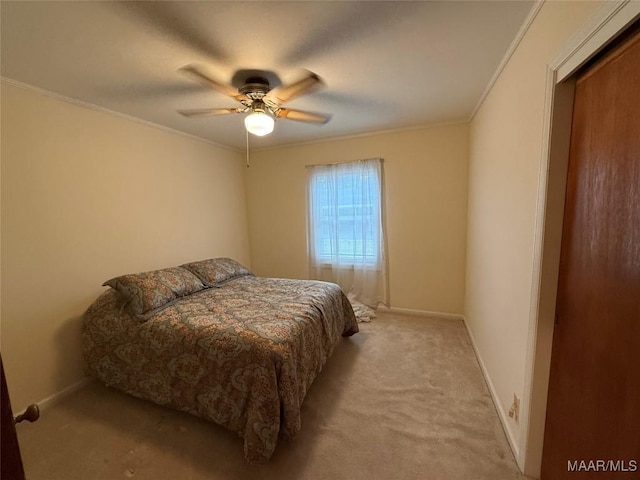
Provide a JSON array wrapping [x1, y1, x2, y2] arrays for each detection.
[[307, 158, 388, 307]]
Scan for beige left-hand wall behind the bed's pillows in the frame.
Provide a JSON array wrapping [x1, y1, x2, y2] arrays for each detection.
[[1, 84, 250, 411]]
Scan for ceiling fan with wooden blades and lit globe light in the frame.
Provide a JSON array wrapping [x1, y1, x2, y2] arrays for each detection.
[[178, 65, 331, 136]]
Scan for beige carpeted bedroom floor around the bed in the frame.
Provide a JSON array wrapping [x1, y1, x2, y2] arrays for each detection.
[[17, 313, 527, 480]]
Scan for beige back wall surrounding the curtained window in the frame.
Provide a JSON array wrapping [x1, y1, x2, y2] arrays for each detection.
[[247, 125, 469, 314]]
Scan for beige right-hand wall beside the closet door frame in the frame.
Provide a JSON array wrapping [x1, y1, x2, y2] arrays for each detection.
[[465, 2, 600, 464]]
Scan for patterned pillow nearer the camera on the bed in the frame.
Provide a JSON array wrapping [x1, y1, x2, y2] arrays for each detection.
[[102, 267, 206, 320]]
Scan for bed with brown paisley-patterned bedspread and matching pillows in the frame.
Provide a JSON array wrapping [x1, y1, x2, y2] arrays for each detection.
[[82, 258, 358, 463]]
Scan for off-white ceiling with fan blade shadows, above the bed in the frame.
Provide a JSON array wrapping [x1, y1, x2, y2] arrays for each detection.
[[0, 0, 534, 149]]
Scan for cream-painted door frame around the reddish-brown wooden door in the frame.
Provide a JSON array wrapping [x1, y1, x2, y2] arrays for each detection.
[[516, 0, 640, 478]]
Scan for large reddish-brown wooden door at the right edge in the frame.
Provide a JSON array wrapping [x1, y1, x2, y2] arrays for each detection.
[[541, 29, 640, 480]]
